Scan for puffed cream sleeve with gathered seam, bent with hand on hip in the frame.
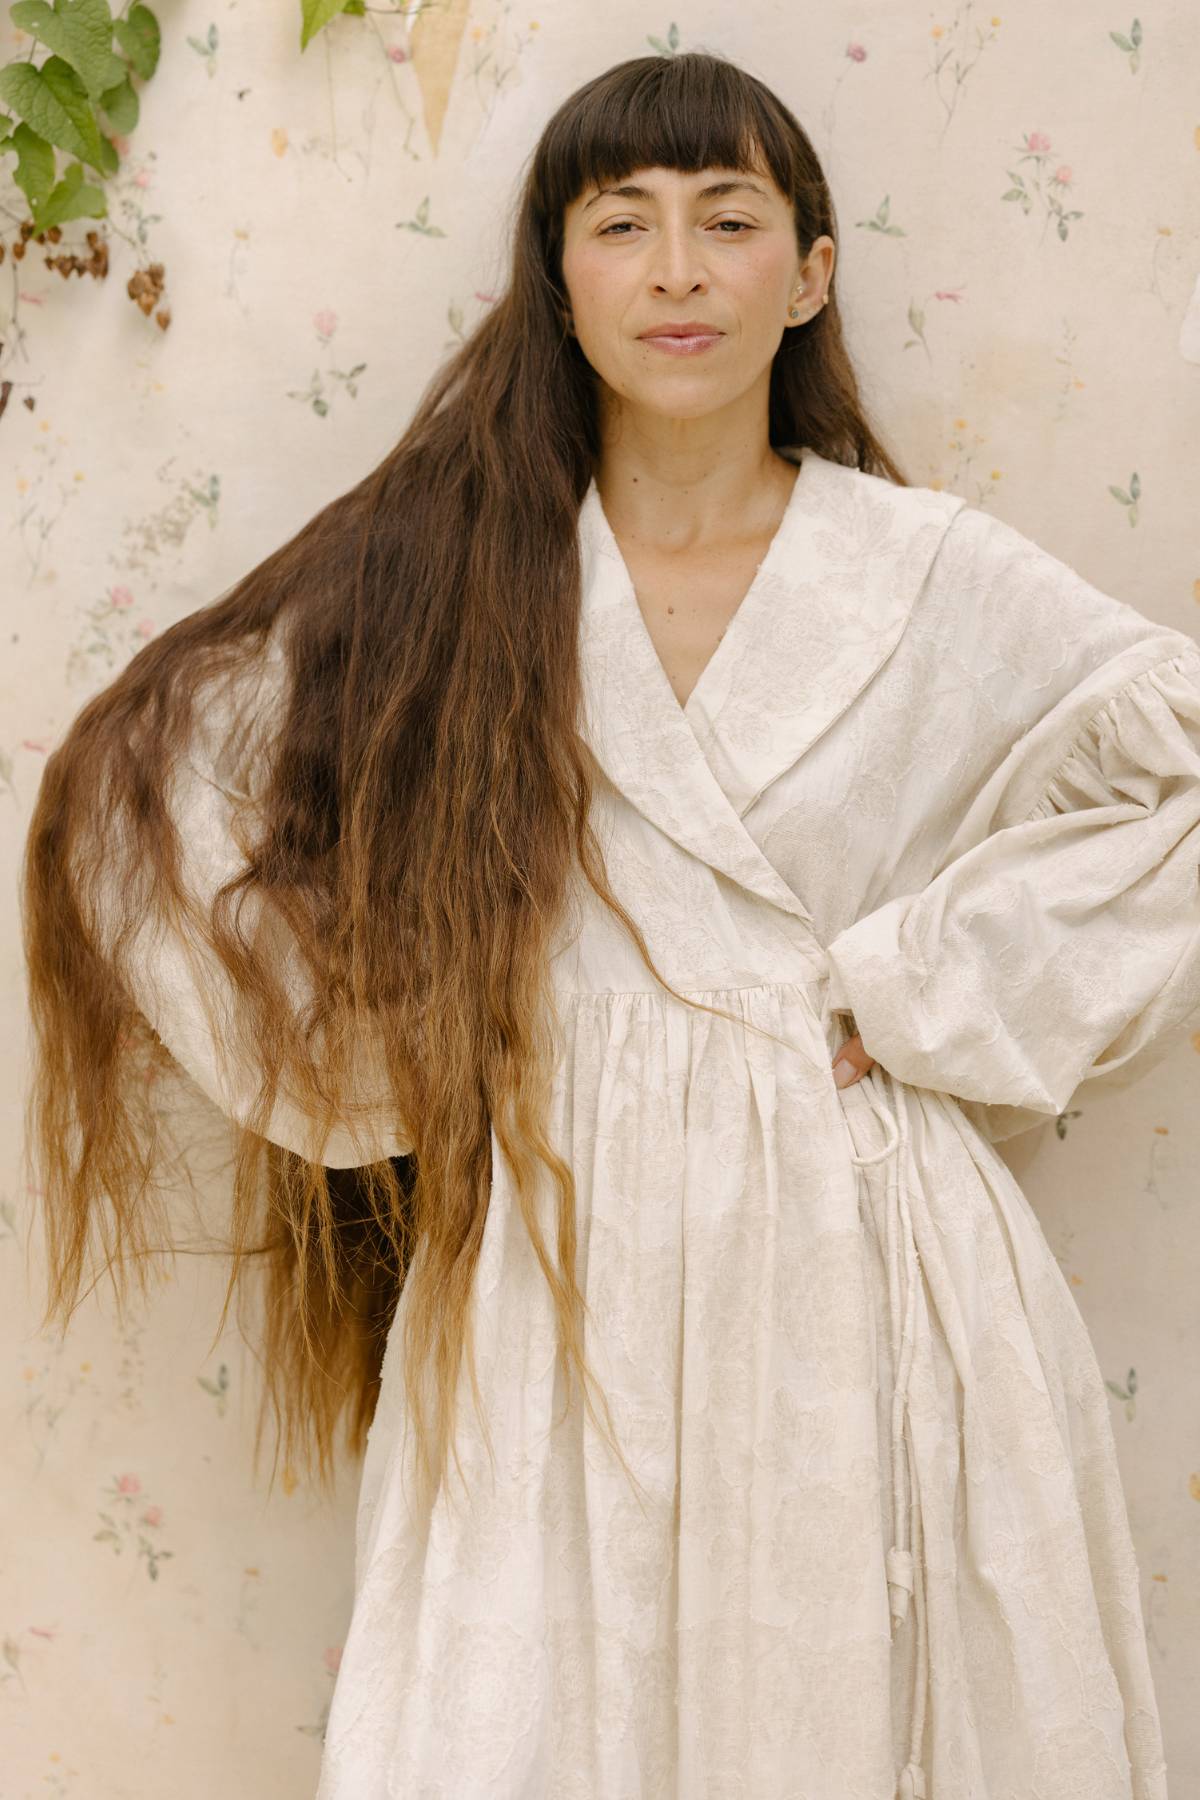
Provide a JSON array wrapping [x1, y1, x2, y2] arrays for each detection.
[[828, 625, 1200, 1139]]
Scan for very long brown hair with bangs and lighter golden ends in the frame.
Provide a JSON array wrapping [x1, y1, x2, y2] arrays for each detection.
[[22, 54, 905, 1519]]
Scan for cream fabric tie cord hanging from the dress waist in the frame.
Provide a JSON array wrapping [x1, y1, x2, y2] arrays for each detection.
[[847, 1080, 928, 1800]]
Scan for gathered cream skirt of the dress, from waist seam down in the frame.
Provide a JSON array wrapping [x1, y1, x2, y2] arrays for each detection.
[[317, 983, 1166, 1800]]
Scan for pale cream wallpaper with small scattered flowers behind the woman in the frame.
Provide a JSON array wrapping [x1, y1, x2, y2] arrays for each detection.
[[0, 0, 1200, 1800]]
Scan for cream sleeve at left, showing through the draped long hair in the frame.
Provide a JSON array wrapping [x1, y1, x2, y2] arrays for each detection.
[[110, 633, 412, 1168]]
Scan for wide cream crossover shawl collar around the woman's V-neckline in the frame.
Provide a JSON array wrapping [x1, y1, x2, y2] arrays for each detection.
[[579, 448, 966, 925]]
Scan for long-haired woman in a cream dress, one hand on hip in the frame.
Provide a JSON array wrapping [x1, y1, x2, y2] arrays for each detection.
[[25, 54, 1200, 1800]]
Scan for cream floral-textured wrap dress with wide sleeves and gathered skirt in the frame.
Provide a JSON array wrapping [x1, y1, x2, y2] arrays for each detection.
[[124, 450, 1200, 1800]]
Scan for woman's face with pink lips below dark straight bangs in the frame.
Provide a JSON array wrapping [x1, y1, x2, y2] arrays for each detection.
[[563, 169, 833, 419]]
